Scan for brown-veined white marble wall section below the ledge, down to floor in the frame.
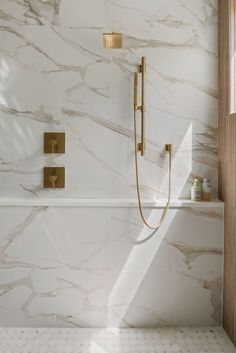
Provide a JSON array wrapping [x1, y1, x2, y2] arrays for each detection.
[[0, 206, 223, 327]]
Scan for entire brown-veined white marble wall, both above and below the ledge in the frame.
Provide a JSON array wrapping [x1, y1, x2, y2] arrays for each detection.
[[0, 0, 220, 327]]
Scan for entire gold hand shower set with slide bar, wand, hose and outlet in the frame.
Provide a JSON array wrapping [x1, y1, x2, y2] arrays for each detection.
[[134, 57, 173, 230]]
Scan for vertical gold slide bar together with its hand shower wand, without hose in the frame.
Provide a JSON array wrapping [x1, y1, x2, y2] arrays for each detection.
[[134, 56, 146, 156]]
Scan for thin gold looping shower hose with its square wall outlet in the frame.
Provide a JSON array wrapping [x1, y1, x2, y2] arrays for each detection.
[[134, 109, 172, 231]]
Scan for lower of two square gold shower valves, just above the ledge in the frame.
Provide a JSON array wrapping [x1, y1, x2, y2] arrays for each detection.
[[43, 167, 65, 189]]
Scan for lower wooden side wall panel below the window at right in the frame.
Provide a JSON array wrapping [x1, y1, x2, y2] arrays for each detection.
[[222, 114, 236, 344]]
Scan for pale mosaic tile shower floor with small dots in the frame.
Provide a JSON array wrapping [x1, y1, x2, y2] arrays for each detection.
[[0, 328, 236, 353]]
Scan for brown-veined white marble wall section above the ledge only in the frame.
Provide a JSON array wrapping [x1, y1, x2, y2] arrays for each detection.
[[0, 0, 217, 197]]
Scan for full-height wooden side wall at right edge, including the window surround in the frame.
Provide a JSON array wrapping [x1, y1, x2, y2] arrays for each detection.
[[219, 0, 236, 345]]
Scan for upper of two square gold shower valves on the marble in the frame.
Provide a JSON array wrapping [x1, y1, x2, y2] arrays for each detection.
[[44, 132, 66, 153]]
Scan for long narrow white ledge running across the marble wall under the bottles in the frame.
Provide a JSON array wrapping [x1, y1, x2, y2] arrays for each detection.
[[0, 198, 224, 208]]
